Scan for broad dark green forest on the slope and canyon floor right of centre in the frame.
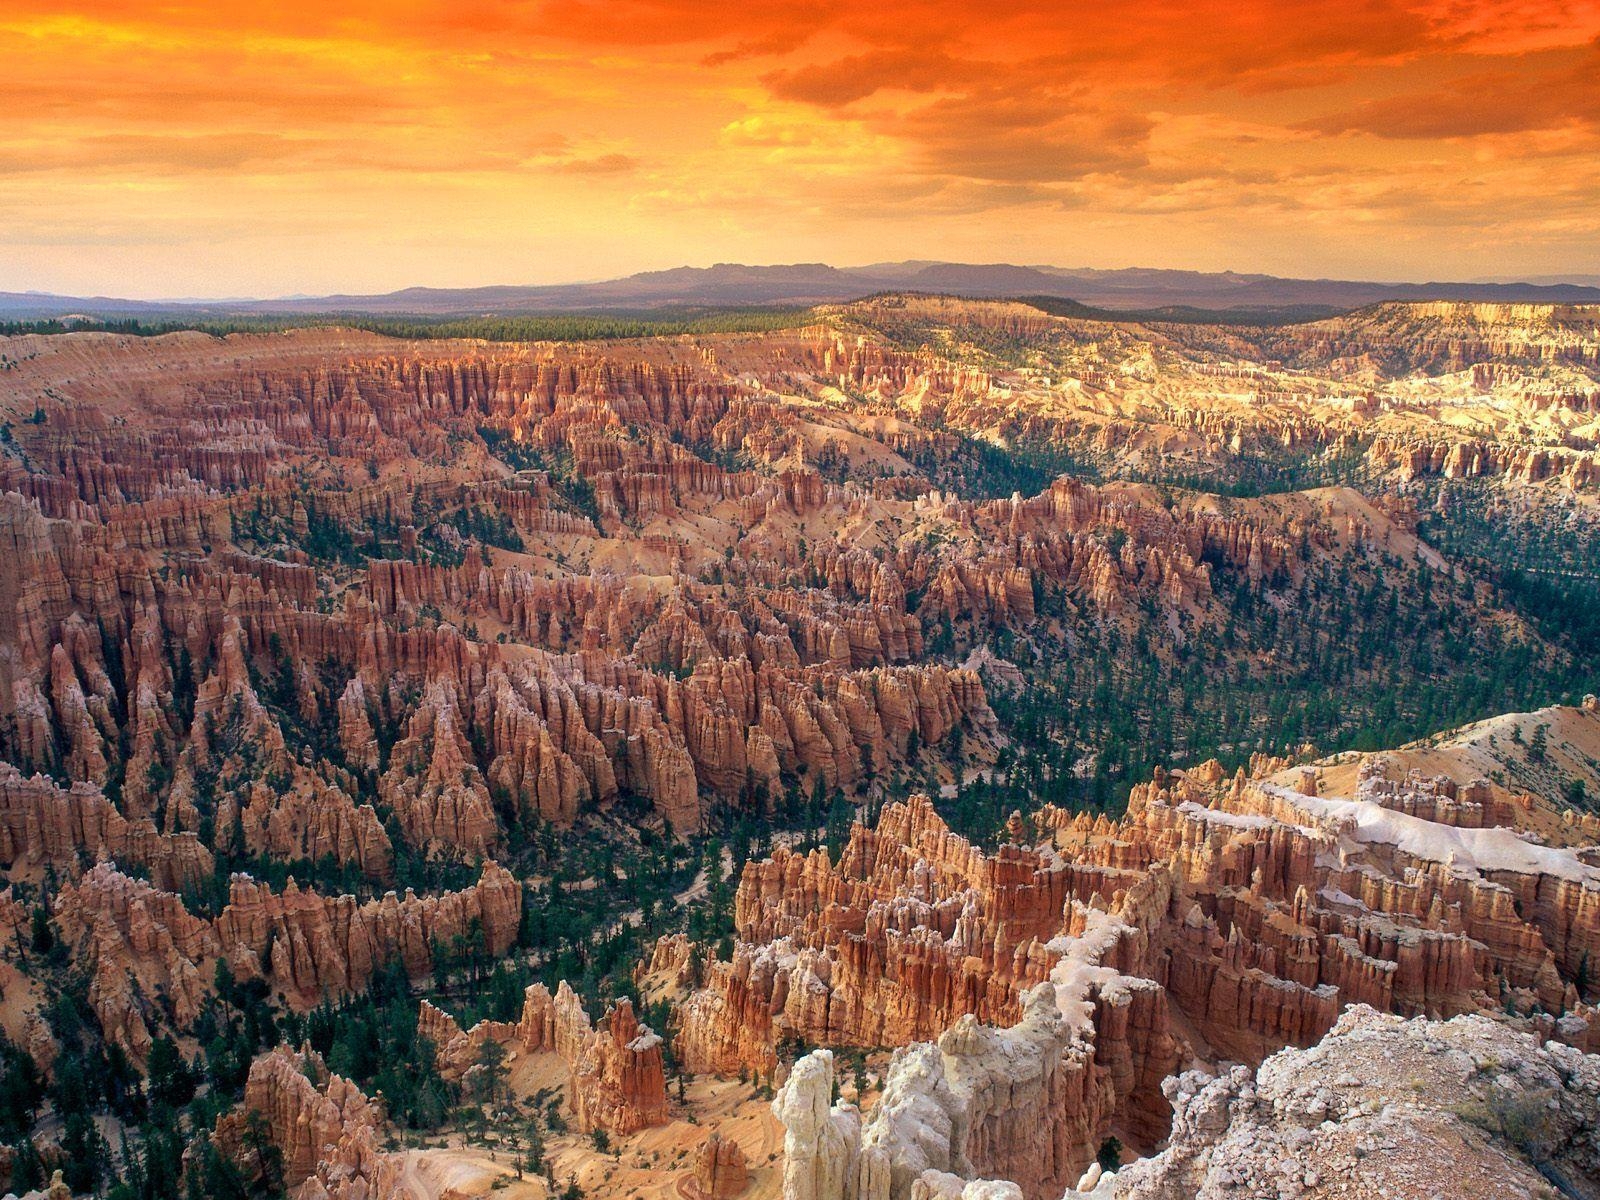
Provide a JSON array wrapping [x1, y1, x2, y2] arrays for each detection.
[[934, 534, 1600, 837]]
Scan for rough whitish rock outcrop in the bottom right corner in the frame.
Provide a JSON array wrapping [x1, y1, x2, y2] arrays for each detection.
[[1112, 1005, 1600, 1200]]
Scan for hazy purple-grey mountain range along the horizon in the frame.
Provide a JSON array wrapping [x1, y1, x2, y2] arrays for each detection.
[[0, 261, 1600, 320]]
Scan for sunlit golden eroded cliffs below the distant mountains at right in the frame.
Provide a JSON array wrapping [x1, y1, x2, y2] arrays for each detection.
[[821, 296, 1600, 490]]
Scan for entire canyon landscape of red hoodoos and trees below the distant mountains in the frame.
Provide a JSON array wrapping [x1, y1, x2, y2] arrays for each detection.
[[0, 296, 1600, 1200]]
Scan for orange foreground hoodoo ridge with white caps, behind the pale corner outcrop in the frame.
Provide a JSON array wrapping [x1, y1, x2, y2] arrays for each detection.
[[697, 729, 1600, 1200]]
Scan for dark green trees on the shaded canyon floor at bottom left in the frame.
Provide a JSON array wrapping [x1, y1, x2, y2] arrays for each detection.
[[0, 830, 675, 1200]]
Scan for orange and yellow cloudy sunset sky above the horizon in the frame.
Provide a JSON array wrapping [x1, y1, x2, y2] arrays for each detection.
[[0, 0, 1600, 298]]
